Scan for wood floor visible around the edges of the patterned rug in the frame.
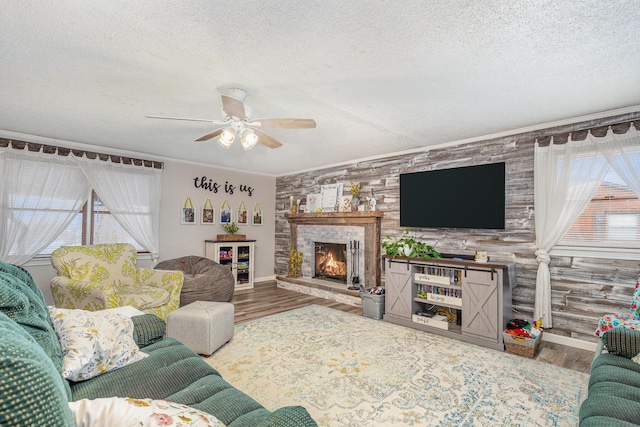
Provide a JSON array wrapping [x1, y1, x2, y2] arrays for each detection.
[[231, 281, 593, 373]]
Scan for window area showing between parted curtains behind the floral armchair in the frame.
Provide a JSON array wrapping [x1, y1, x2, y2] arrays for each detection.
[[40, 191, 146, 255]]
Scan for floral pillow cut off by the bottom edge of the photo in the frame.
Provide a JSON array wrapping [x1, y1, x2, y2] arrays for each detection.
[[69, 397, 225, 427]]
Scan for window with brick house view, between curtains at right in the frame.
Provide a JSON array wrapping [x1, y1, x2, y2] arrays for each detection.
[[554, 169, 640, 254]]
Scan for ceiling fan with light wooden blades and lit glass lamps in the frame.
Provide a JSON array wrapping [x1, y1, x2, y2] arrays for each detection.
[[147, 88, 316, 150]]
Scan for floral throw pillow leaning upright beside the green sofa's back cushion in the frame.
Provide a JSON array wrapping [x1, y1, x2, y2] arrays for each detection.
[[49, 307, 148, 381]]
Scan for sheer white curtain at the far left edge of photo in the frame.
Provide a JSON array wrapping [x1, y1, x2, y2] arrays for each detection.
[[0, 147, 90, 265]]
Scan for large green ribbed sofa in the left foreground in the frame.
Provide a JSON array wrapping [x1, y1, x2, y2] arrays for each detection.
[[0, 262, 317, 427]]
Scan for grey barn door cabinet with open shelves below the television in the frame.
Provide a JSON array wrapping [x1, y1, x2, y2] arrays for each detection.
[[383, 256, 515, 351]]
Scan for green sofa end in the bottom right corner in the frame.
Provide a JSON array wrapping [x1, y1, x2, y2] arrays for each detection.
[[580, 327, 640, 427]]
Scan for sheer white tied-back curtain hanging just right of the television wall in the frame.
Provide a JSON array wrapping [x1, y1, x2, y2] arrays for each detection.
[[534, 137, 609, 328]]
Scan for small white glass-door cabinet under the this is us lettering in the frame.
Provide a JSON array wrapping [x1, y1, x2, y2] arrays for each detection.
[[204, 240, 255, 290]]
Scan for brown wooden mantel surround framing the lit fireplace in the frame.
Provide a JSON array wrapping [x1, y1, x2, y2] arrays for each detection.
[[285, 211, 384, 288]]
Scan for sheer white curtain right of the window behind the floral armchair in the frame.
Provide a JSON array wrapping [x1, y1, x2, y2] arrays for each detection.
[[74, 156, 162, 265]]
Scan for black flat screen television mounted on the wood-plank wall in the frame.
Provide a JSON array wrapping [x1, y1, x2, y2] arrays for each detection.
[[400, 162, 505, 229]]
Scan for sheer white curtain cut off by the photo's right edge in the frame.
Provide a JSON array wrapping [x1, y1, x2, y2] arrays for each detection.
[[587, 124, 640, 198]]
